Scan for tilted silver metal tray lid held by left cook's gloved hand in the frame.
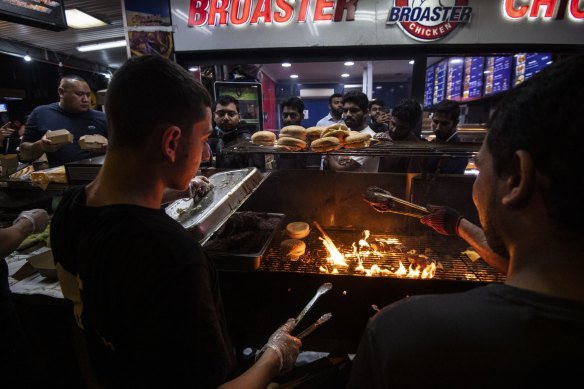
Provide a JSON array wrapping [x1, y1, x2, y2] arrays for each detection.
[[165, 168, 270, 244]]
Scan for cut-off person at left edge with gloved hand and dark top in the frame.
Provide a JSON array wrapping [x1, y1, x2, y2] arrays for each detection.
[[0, 209, 49, 387]]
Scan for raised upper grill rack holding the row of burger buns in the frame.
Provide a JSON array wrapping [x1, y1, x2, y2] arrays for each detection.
[[224, 141, 480, 158]]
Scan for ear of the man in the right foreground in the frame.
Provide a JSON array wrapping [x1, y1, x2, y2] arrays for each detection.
[[502, 150, 536, 205]]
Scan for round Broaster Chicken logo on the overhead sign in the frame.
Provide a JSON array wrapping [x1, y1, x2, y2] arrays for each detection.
[[387, 0, 472, 42]]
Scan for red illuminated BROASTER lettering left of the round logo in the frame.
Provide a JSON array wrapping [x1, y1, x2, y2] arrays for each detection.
[[188, 0, 358, 27]]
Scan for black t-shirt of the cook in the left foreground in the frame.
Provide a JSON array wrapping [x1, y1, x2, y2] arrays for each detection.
[[51, 187, 235, 388]]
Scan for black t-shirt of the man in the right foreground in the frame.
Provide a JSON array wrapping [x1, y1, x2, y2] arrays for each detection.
[[348, 284, 584, 388]]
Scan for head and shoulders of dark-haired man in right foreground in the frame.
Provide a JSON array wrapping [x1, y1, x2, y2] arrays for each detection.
[[348, 54, 584, 388]]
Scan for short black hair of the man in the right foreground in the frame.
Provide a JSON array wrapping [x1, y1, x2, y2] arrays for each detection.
[[486, 55, 584, 230]]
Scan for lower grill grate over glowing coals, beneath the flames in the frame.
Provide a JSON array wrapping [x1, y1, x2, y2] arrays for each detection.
[[258, 224, 505, 282]]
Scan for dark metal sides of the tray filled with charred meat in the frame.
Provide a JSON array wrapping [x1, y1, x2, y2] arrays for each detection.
[[203, 212, 286, 271]]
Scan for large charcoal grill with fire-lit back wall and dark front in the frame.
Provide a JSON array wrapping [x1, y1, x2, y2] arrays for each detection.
[[213, 170, 504, 353]]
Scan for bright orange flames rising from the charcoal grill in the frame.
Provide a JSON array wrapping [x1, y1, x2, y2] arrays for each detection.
[[319, 228, 437, 278]]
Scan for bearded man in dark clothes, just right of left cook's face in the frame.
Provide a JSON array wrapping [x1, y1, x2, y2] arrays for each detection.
[[209, 95, 263, 169]]
